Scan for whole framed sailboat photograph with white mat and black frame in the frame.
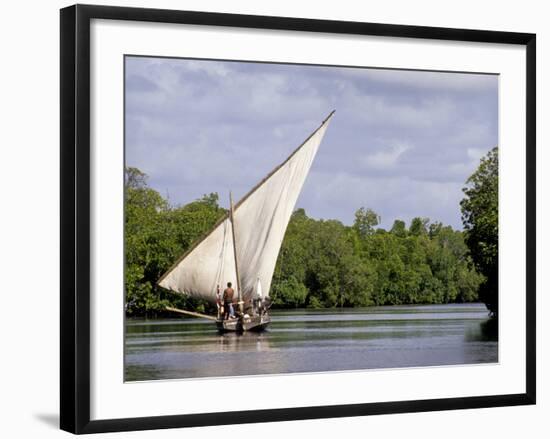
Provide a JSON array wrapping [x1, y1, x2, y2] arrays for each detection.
[[60, 5, 536, 433]]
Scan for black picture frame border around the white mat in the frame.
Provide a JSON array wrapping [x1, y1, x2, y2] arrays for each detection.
[[60, 5, 536, 434]]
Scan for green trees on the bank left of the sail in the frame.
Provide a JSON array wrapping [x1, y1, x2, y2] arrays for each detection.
[[124, 168, 225, 316]]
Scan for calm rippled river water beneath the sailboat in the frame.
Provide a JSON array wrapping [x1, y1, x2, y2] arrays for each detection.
[[125, 304, 498, 381]]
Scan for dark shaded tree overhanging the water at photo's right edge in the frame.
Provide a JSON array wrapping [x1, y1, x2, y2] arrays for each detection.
[[460, 147, 498, 316]]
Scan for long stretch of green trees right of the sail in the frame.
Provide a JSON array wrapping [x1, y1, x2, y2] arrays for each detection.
[[271, 208, 483, 308]]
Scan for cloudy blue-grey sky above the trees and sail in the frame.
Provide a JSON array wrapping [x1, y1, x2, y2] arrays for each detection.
[[125, 57, 498, 229]]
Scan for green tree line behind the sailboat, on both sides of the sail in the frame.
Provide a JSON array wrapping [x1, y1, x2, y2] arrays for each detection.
[[125, 162, 488, 315]]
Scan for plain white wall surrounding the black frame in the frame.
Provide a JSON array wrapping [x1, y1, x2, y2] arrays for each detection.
[[0, 0, 550, 439]]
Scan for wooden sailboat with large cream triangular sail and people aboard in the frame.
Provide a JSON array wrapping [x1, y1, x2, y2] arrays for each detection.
[[158, 111, 334, 332]]
